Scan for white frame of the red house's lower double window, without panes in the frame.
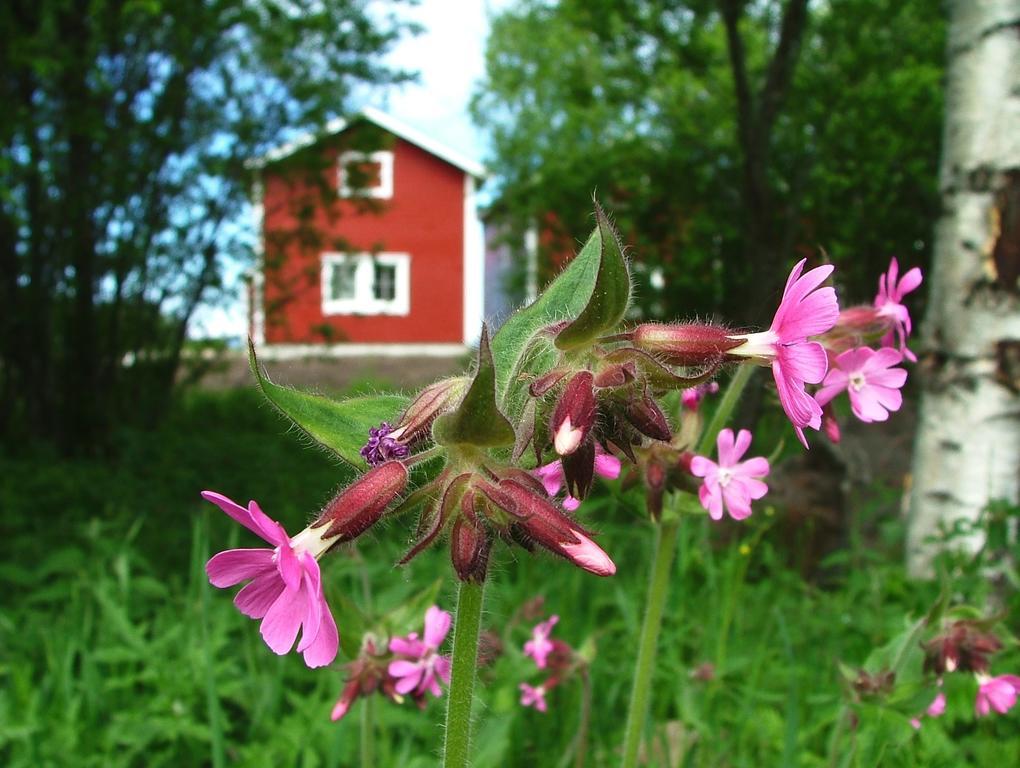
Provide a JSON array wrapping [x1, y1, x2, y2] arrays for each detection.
[[321, 248, 411, 316]]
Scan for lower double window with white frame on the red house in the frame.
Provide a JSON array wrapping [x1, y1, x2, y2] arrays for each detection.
[[322, 253, 411, 315]]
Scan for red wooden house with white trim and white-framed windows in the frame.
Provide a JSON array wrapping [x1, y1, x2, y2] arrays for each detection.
[[248, 108, 486, 358]]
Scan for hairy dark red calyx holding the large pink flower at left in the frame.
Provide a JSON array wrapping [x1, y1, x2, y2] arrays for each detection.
[[309, 461, 408, 546]]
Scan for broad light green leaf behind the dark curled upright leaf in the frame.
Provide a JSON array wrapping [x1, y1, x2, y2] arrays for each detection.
[[493, 210, 602, 418]]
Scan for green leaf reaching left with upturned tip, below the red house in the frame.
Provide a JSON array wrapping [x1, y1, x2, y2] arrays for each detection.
[[248, 341, 408, 469]]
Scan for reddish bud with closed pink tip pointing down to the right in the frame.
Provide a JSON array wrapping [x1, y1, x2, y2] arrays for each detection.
[[500, 480, 616, 576]]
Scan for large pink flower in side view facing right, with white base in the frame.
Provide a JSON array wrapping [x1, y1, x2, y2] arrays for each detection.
[[728, 259, 839, 448]]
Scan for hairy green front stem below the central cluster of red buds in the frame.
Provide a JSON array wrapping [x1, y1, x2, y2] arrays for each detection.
[[443, 581, 482, 768]]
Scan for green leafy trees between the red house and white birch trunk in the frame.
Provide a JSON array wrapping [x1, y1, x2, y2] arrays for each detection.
[[473, 0, 945, 321]]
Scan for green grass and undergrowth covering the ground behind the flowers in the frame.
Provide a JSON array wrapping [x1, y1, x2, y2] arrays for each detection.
[[0, 391, 1020, 768]]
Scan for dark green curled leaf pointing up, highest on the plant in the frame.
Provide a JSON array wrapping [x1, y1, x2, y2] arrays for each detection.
[[556, 203, 630, 350]]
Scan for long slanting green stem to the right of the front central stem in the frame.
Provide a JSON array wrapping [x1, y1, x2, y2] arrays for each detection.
[[621, 512, 680, 768]]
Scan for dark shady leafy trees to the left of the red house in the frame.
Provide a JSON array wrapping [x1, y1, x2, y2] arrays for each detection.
[[0, 0, 408, 449]]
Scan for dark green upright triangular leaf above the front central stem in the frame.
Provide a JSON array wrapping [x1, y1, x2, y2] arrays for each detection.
[[432, 325, 516, 448]]
